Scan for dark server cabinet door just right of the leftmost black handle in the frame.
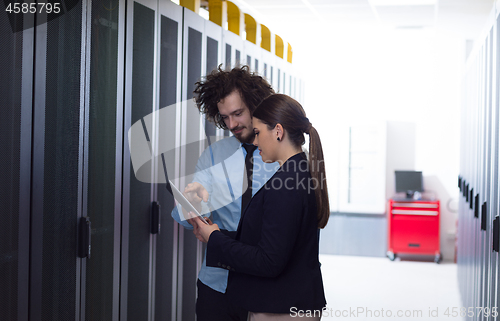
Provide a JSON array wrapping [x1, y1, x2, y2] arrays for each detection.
[[82, 0, 125, 320]]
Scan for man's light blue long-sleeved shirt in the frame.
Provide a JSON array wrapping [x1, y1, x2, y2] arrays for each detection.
[[172, 136, 279, 293]]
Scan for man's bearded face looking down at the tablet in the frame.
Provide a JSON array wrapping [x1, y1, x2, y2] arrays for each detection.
[[217, 90, 255, 143]]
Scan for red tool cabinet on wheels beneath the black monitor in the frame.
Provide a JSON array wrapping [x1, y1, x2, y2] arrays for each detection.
[[387, 199, 442, 263]]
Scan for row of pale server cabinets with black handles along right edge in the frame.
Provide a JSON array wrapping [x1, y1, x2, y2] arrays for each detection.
[[457, 8, 500, 320]]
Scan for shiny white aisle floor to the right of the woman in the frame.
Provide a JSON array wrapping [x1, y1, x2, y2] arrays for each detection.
[[320, 254, 462, 321]]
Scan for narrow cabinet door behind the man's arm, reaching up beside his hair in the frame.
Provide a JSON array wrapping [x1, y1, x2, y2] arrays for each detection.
[[177, 8, 206, 321]]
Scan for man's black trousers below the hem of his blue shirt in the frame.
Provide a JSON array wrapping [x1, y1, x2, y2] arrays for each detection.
[[196, 280, 248, 321]]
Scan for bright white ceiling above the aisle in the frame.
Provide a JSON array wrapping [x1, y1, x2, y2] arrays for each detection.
[[233, 0, 495, 39]]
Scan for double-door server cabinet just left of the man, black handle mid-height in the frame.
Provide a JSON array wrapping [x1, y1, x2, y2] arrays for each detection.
[[120, 0, 182, 320]]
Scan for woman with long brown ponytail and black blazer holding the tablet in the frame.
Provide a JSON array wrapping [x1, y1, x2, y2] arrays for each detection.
[[194, 94, 330, 321]]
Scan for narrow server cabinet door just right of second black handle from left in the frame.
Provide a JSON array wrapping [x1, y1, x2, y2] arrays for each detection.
[[154, 1, 182, 320]]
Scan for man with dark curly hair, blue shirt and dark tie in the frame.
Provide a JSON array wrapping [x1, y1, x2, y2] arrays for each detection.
[[172, 66, 278, 321]]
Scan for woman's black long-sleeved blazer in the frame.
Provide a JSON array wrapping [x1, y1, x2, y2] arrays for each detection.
[[206, 153, 326, 313]]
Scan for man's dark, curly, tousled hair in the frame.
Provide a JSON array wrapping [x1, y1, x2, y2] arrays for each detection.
[[194, 64, 274, 129]]
